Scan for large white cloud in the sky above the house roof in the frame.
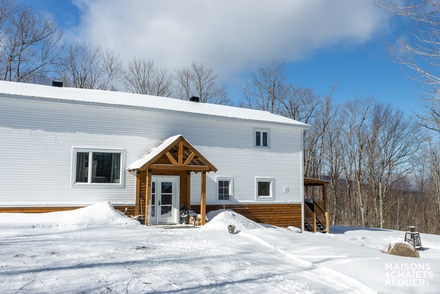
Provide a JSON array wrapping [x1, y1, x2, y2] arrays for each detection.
[[71, 0, 388, 78]]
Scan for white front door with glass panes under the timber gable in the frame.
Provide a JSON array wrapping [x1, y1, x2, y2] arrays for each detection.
[[149, 176, 180, 224]]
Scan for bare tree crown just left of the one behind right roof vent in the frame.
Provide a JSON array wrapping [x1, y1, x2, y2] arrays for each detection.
[[123, 58, 173, 97]]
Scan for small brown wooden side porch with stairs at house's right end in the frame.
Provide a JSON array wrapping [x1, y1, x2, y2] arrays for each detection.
[[304, 178, 330, 233]]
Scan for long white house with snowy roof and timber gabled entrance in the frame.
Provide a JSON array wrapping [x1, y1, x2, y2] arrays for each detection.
[[0, 81, 308, 227]]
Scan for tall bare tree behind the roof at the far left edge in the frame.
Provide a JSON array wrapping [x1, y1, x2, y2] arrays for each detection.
[[0, 0, 62, 83]]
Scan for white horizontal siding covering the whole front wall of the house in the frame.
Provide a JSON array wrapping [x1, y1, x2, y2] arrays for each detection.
[[0, 97, 303, 206]]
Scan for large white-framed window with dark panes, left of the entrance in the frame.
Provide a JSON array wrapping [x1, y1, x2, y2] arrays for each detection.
[[72, 148, 124, 186]]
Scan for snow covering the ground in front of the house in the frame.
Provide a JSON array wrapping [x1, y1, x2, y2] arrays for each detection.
[[0, 202, 440, 293]]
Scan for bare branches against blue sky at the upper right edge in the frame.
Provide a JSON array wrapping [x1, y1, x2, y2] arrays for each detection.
[[375, 0, 440, 132]]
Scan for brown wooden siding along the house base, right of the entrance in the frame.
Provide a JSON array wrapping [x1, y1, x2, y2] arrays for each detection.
[[191, 204, 302, 228]]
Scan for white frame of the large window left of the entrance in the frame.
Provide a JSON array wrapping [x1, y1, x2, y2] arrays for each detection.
[[71, 147, 125, 188]]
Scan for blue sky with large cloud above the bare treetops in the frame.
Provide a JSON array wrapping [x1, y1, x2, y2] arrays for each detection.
[[19, 0, 423, 113]]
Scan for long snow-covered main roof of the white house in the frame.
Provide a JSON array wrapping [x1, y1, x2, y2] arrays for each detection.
[[0, 81, 309, 129]]
